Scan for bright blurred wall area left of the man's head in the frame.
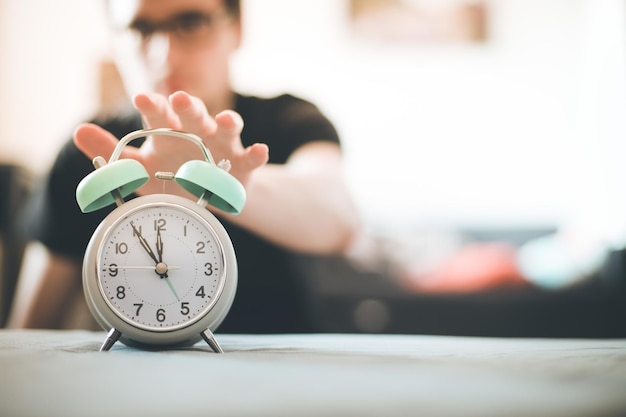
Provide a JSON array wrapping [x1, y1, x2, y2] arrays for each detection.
[[0, 0, 106, 172]]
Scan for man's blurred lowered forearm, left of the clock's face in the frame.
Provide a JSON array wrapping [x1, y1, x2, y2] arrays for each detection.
[[8, 243, 81, 329]]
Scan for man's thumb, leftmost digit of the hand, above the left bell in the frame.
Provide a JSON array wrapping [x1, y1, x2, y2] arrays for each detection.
[[74, 123, 142, 161]]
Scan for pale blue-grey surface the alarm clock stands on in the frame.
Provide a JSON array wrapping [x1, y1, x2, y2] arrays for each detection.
[[0, 330, 626, 417]]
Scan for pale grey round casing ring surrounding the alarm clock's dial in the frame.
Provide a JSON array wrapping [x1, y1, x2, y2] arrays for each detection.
[[83, 194, 237, 345]]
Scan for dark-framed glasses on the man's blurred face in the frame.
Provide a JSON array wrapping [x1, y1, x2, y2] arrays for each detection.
[[128, 10, 229, 44]]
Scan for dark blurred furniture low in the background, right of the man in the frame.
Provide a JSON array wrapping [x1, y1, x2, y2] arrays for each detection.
[[299, 245, 626, 338]]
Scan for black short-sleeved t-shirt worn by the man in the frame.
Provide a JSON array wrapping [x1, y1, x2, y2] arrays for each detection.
[[27, 95, 339, 333]]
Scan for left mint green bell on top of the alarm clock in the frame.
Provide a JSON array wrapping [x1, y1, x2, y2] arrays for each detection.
[[76, 159, 149, 213]]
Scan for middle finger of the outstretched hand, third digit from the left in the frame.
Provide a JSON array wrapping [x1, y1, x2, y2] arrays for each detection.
[[169, 91, 217, 137]]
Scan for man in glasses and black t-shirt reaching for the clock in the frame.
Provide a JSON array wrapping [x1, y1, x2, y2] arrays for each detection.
[[9, 0, 358, 333]]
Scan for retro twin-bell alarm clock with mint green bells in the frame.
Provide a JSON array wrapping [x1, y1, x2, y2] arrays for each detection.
[[76, 129, 246, 352]]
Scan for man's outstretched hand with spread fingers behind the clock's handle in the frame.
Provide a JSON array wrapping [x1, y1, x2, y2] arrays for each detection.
[[74, 91, 269, 194]]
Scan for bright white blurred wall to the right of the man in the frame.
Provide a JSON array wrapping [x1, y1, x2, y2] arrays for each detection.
[[237, 0, 626, 231]]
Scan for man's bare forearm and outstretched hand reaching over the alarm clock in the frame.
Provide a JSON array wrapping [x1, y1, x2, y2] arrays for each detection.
[[74, 92, 357, 253]]
